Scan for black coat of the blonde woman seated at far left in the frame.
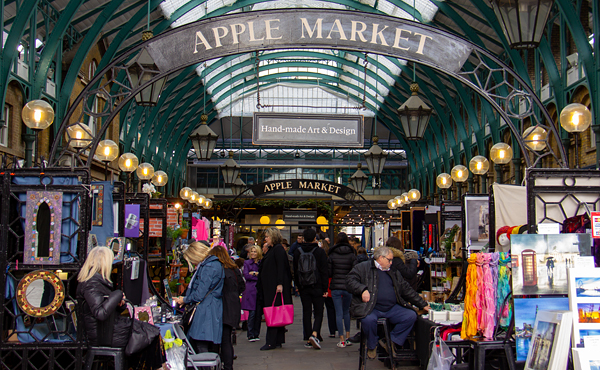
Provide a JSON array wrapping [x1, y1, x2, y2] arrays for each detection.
[[77, 273, 131, 347]]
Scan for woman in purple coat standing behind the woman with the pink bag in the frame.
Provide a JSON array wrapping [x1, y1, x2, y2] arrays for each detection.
[[242, 245, 262, 342]]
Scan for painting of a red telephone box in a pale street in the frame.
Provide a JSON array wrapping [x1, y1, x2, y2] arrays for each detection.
[[510, 234, 592, 296]]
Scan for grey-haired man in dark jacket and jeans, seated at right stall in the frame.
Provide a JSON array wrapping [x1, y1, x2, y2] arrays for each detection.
[[346, 247, 430, 359]]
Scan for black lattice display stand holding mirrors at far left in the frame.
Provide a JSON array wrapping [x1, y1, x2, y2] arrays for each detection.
[[0, 161, 91, 369]]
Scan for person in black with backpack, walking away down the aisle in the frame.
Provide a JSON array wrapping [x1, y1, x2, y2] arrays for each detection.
[[294, 228, 329, 349]]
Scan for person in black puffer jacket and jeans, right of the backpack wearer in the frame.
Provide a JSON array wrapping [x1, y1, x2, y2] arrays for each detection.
[[327, 233, 357, 348]]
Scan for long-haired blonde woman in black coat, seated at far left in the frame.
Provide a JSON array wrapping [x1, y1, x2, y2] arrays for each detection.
[[77, 247, 164, 369]]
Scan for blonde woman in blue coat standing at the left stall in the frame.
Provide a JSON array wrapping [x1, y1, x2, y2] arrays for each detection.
[[175, 240, 225, 353]]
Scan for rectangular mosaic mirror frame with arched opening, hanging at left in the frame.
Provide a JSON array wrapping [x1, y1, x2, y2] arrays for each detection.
[[23, 191, 63, 265]]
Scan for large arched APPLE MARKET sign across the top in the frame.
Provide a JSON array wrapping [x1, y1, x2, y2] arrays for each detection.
[[148, 9, 472, 73]]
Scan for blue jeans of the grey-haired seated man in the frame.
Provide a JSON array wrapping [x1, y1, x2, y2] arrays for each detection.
[[360, 305, 417, 349]]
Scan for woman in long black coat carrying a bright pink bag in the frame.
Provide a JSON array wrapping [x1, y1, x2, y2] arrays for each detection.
[[257, 227, 292, 351]]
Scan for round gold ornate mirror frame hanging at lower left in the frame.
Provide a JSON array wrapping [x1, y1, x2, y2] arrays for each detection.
[[16, 270, 65, 317]]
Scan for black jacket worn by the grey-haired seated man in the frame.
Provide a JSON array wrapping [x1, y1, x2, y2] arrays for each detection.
[[346, 260, 427, 319]]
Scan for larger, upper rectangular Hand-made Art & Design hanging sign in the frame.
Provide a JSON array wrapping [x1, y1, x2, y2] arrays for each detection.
[[252, 113, 364, 148]]
